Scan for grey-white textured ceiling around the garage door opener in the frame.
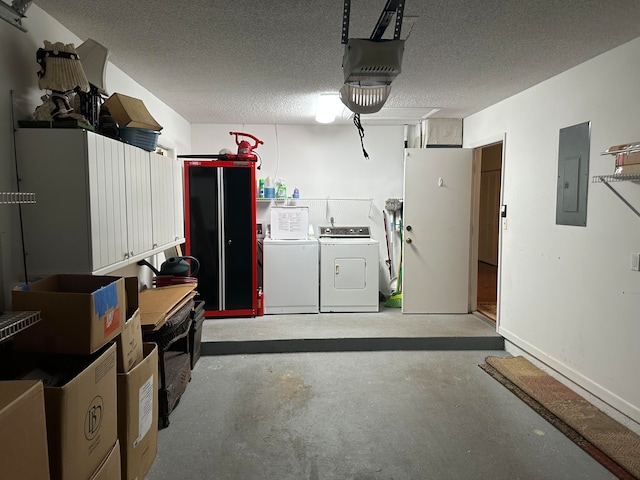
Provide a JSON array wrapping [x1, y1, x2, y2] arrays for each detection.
[[27, 0, 640, 124]]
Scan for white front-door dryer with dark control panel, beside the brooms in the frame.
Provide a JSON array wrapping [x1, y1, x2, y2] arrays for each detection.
[[319, 227, 379, 312]]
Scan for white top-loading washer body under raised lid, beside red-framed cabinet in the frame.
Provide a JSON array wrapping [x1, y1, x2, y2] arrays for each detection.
[[262, 238, 320, 315]]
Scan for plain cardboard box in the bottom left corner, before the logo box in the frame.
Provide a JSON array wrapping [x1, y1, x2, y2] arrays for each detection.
[[0, 380, 49, 480]]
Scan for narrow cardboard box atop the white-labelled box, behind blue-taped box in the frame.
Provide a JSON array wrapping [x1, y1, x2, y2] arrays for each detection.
[[116, 277, 143, 373]]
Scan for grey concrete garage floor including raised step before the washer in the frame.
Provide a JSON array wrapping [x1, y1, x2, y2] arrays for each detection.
[[146, 312, 615, 480]]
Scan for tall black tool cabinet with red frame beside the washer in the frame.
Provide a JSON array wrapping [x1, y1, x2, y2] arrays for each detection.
[[182, 155, 257, 318]]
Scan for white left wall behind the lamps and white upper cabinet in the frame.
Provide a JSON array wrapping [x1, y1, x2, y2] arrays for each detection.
[[0, 4, 191, 309]]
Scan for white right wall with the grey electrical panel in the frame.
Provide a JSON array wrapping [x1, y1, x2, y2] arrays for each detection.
[[464, 38, 640, 422]]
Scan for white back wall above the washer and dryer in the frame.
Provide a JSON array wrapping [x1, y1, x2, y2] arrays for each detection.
[[191, 125, 404, 293]]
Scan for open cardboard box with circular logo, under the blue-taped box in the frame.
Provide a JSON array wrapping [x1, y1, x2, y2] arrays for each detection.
[[0, 342, 118, 480]]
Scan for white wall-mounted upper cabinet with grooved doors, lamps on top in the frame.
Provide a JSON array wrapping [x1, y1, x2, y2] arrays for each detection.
[[16, 129, 184, 276]]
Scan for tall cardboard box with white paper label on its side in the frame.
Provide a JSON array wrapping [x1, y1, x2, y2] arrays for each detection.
[[118, 343, 159, 480]]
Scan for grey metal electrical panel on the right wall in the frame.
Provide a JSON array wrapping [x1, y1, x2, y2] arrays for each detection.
[[556, 122, 591, 227]]
